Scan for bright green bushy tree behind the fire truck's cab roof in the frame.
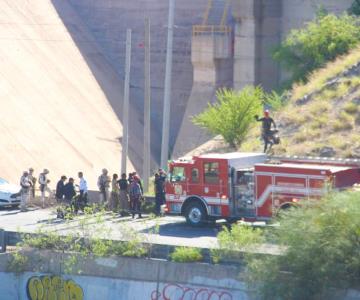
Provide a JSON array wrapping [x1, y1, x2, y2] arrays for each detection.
[[193, 86, 265, 147]]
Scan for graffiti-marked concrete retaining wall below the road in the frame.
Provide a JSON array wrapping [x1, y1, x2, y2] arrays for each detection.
[[0, 252, 254, 300]]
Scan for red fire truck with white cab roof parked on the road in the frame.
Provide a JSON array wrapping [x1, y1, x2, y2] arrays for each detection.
[[165, 153, 360, 226]]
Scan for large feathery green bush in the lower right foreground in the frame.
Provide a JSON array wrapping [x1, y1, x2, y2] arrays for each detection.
[[215, 192, 360, 300]]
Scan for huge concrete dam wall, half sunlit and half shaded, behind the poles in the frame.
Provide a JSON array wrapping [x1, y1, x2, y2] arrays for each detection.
[[0, 0, 352, 187]]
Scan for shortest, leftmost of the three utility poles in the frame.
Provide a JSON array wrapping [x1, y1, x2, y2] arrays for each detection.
[[121, 29, 131, 174]]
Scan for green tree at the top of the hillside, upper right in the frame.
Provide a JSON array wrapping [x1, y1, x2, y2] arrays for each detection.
[[273, 13, 360, 82]]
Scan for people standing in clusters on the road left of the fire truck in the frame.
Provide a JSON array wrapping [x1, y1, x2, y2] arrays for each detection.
[[20, 168, 166, 218]]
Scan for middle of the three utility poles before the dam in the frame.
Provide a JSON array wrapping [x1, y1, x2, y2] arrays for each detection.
[[143, 17, 151, 192]]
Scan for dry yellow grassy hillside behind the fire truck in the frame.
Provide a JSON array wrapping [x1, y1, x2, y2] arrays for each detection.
[[189, 48, 360, 158]]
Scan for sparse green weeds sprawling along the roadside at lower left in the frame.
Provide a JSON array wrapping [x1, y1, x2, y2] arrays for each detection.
[[8, 207, 151, 273]]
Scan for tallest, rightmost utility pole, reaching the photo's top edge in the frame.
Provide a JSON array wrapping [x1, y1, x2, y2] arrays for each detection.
[[160, 0, 175, 169]]
